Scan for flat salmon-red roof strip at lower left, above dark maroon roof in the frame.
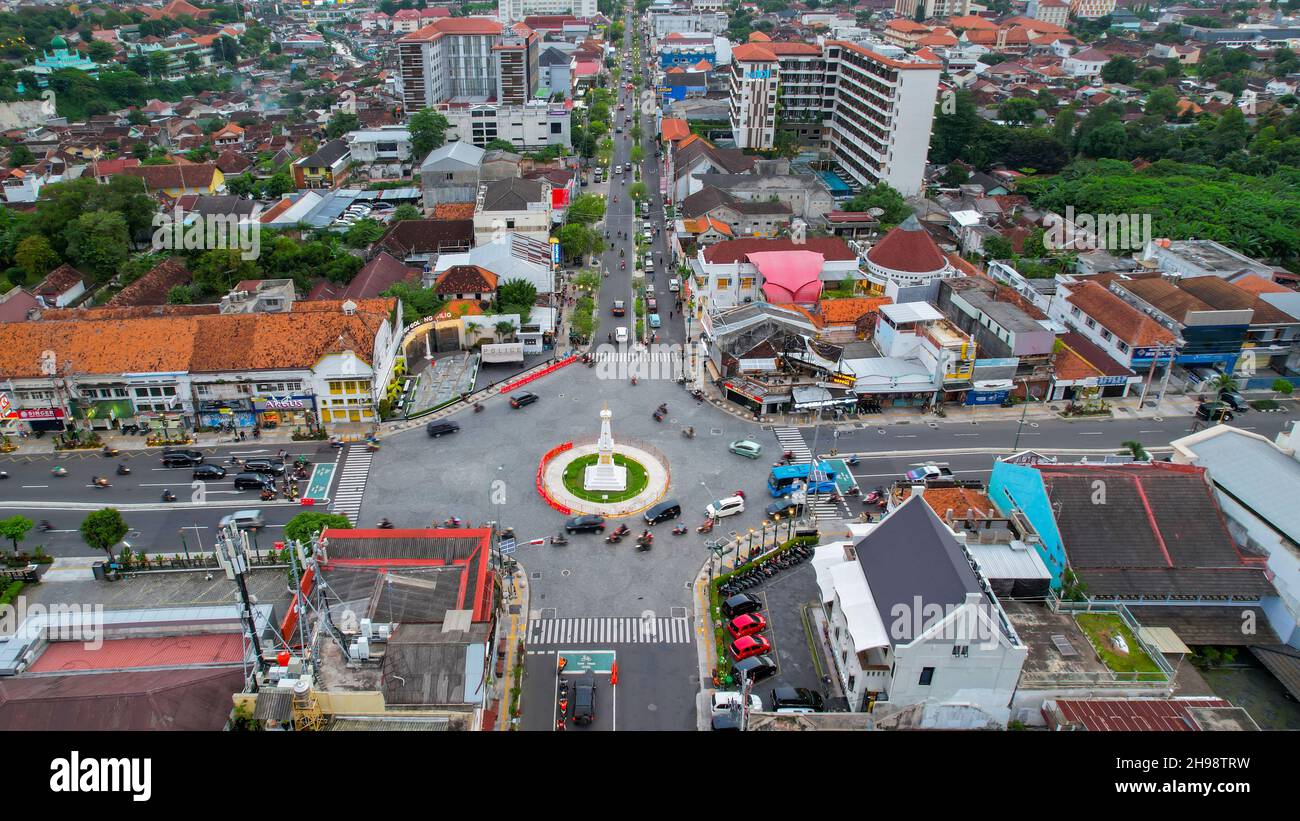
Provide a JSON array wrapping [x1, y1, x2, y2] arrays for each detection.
[[30, 633, 243, 673]]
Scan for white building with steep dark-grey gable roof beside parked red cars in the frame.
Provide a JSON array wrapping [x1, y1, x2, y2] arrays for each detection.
[[813, 492, 1028, 725]]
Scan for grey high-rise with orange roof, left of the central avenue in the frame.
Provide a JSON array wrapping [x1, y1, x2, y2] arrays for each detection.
[[398, 17, 506, 112]]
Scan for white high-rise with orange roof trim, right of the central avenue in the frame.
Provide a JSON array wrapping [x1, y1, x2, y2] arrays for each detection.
[[731, 40, 943, 196]]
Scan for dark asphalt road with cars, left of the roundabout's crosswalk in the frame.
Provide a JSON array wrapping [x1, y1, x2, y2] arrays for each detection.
[[0, 442, 337, 557]]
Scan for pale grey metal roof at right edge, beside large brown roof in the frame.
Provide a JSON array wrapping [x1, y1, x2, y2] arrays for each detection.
[[1188, 426, 1300, 543]]
